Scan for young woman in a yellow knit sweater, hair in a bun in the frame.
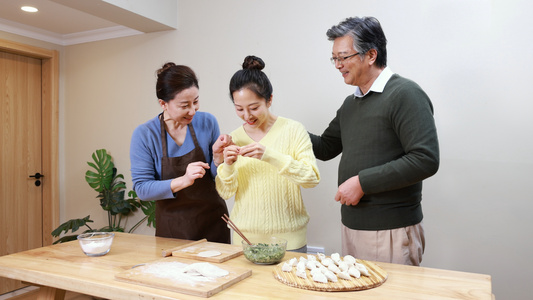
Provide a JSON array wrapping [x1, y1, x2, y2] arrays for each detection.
[[216, 56, 320, 252]]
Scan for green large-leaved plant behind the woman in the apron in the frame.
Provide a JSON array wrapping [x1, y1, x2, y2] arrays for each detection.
[[52, 149, 155, 244]]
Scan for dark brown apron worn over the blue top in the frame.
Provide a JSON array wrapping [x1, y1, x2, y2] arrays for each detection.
[[155, 115, 230, 243]]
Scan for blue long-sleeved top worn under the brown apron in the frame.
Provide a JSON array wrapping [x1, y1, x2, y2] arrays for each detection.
[[130, 112, 220, 201]]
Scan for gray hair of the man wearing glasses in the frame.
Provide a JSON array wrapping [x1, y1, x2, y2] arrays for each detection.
[[326, 17, 387, 68]]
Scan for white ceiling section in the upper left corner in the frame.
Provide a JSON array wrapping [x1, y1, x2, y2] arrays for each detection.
[[0, 0, 177, 45]]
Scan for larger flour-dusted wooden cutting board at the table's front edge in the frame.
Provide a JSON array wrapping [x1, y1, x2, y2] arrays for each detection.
[[115, 256, 252, 298]]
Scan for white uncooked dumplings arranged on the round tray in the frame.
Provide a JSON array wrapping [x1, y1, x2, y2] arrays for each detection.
[[281, 253, 370, 283]]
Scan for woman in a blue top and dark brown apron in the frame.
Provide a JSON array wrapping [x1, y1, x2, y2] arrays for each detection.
[[130, 63, 230, 243]]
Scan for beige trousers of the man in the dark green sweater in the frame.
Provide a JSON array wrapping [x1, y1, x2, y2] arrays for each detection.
[[341, 222, 425, 266]]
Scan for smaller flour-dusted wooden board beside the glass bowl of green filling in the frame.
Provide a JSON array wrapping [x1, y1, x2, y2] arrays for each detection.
[[172, 241, 243, 263]]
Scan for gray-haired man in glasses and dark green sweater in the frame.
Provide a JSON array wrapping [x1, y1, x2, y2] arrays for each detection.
[[310, 17, 439, 265]]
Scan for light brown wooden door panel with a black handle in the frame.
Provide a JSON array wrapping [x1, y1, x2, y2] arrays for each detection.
[[0, 52, 46, 294]]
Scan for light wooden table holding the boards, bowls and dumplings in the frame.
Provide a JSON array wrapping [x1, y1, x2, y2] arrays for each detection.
[[0, 233, 492, 300]]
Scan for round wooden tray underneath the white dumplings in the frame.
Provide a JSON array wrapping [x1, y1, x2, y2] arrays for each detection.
[[273, 255, 388, 292]]
